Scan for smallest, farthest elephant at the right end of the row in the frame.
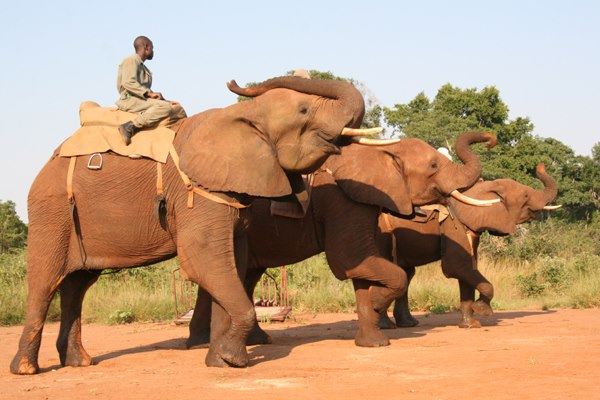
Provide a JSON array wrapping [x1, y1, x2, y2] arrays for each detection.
[[377, 164, 559, 328]]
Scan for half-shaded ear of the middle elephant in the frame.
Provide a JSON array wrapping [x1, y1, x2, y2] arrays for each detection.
[[327, 144, 413, 215]]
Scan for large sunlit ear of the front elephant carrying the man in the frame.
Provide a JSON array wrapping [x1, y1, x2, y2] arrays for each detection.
[[178, 109, 292, 197]]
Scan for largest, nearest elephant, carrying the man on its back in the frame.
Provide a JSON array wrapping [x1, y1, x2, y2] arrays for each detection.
[[10, 77, 372, 374]]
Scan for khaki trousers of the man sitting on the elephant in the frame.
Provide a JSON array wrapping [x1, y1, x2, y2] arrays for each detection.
[[117, 96, 186, 128]]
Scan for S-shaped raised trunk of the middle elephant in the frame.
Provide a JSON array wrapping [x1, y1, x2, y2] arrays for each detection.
[[440, 132, 496, 194]]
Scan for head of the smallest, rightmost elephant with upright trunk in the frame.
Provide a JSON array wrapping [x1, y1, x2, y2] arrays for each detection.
[[451, 164, 560, 236]]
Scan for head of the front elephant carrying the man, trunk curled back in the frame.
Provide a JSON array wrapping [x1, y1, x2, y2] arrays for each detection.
[[178, 76, 365, 197]]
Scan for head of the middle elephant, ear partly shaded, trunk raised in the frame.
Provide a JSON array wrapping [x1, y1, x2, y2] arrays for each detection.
[[326, 132, 496, 215]]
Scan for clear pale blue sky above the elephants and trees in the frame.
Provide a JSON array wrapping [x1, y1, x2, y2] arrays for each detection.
[[0, 0, 600, 220]]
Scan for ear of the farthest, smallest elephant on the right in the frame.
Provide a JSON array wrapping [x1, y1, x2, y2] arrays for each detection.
[[449, 181, 517, 236]]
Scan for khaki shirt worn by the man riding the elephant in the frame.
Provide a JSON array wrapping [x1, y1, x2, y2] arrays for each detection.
[[117, 54, 152, 100]]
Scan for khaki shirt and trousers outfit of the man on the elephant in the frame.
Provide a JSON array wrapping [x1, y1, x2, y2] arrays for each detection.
[[117, 54, 186, 128]]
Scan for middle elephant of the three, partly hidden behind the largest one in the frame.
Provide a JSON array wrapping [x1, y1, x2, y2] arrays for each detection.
[[187, 132, 495, 347]]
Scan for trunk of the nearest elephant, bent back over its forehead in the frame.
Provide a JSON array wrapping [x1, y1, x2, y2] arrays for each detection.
[[227, 76, 365, 128]]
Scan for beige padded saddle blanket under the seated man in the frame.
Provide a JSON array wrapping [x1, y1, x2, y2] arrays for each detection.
[[59, 101, 182, 163]]
